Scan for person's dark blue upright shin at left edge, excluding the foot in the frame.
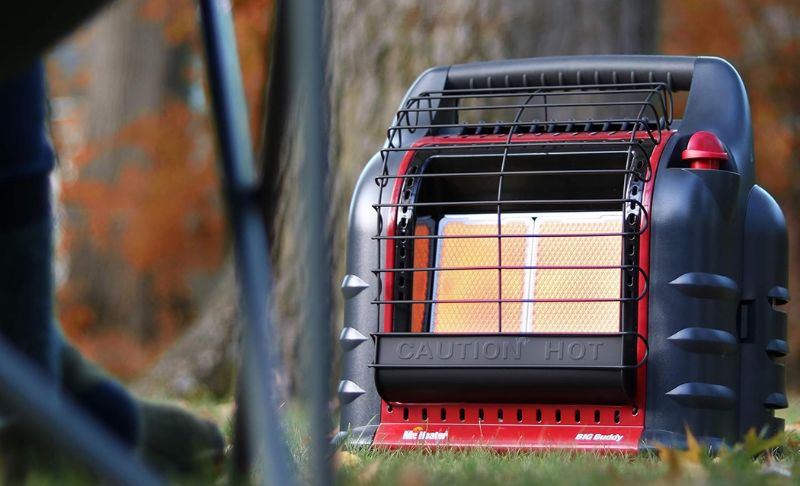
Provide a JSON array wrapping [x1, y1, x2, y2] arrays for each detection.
[[0, 64, 60, 377]]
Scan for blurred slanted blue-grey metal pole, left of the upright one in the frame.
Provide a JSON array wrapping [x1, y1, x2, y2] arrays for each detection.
[[199, 0, 293, 485]]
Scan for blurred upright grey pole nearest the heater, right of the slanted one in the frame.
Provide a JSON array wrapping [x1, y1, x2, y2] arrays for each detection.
[[286, 0, 333, 485]]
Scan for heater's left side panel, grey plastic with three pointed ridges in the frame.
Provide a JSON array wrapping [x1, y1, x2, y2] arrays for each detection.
[[334, 66, 450, 444]]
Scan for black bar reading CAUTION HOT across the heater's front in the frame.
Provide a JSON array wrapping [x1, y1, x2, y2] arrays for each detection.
[[370, 332, 647, 404]]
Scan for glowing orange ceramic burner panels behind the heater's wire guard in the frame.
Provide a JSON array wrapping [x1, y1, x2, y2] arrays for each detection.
[[428, 212, 622, 333]]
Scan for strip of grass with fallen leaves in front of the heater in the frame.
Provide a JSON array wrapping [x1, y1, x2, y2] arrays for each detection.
[[322, 402, 800, 486]]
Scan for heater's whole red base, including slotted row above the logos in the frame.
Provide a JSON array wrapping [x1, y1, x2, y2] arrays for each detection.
[[366, 402, 644, 453]]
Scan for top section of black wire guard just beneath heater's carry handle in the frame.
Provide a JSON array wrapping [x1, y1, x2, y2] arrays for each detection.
[[385, 83, 673, 150]]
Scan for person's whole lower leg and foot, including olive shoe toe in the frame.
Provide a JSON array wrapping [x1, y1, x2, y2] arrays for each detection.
[[0, 64, 224, 479]]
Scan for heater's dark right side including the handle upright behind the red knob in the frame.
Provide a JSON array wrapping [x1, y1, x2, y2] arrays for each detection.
[[643, 57, 754, 446]]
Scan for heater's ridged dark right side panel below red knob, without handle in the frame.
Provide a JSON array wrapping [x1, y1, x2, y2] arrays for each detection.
[[643, 139, 746, 447]]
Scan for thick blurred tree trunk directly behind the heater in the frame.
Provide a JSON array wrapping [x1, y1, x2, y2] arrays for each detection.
[[147, 0, 658, 389]]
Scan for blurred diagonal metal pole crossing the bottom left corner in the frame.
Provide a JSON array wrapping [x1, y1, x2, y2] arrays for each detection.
[[0, 337, 164, 486]]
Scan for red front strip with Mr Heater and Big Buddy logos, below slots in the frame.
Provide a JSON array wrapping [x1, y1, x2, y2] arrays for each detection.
[[372, 423, 642, 453]]
